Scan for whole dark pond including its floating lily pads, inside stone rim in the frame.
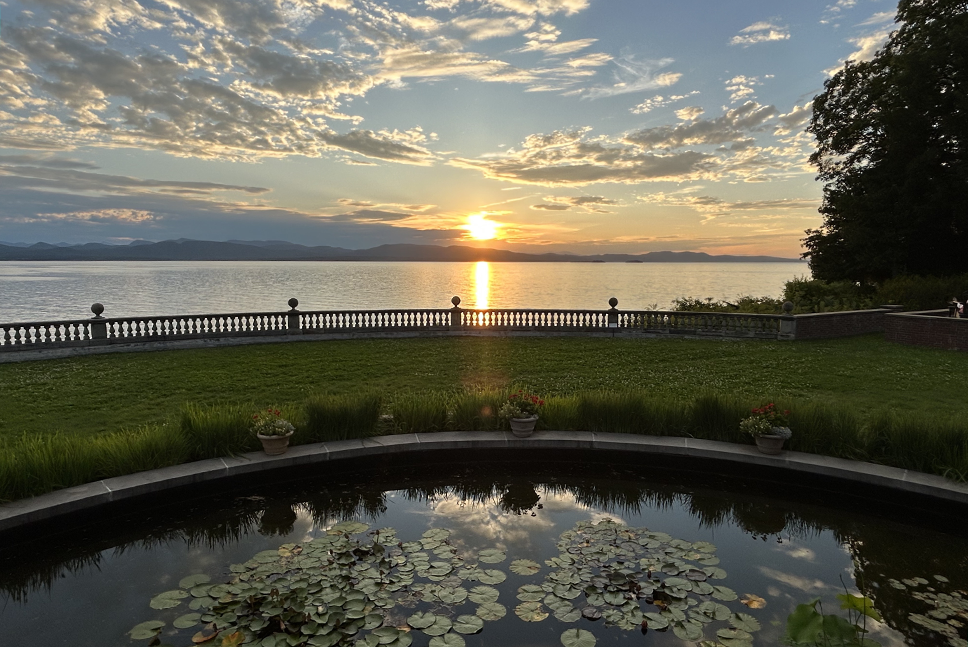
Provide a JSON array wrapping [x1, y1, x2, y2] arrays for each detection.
[[0, 456, 968, 647]]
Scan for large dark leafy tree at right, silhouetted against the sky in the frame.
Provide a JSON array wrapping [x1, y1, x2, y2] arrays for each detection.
[[803, 0, 968, 283]]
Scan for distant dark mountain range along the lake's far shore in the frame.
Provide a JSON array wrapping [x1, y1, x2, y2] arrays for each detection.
[[0, 238, 799, 263]]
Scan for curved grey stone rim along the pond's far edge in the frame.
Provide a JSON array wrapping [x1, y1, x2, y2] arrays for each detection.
[[0, 431, 968, 533]]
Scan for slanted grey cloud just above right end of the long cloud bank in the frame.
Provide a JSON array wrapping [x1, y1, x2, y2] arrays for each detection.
[[624, 101, 777, 150]]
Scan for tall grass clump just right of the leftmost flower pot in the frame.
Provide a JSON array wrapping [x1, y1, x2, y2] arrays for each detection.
[[304, 391, 383, 443]]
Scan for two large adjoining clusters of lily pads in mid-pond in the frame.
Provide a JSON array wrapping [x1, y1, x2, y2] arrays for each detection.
[[129, 519, 762, 647]]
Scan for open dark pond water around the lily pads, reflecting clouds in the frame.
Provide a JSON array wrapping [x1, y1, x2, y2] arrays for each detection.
[[0, 463, 968, 647]]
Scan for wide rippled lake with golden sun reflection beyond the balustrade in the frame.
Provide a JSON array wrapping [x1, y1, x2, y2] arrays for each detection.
[[0, 261, 810, 323]]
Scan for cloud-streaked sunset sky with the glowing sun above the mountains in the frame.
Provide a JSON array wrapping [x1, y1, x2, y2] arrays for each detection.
[[0, 0, 896, 257]]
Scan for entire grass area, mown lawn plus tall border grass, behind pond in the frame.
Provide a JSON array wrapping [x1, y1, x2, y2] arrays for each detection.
[[0, 336, 968, 500]]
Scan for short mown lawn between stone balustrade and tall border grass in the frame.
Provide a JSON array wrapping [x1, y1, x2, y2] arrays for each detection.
[[0, 335, 968, 439]]
